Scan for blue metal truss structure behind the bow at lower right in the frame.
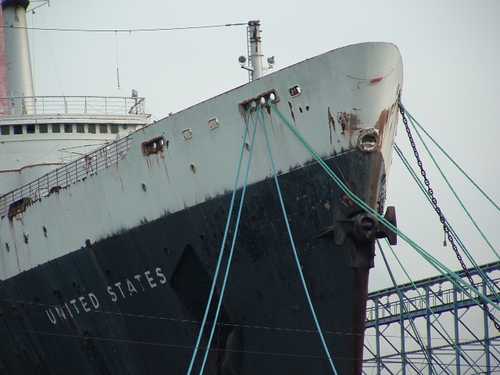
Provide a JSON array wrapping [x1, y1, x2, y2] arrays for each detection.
[[363, 261, 500, 375]]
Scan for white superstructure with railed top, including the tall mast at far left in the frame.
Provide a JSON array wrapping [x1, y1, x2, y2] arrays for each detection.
[[0, 0, 150, 196]]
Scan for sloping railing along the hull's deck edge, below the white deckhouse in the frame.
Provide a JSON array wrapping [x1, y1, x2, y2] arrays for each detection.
[[0, 136, 132, 217]]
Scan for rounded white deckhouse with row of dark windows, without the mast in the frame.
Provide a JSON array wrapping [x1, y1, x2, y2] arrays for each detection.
[[0, 97, 150, 195]]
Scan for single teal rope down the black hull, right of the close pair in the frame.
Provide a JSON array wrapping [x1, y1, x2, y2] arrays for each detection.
[[260, 111, 337, 375]]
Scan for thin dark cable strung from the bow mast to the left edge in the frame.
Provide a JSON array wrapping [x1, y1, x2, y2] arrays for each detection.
[[0, 22, 247, 34]]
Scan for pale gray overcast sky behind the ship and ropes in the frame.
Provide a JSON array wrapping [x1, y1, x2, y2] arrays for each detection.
[[24, 0, 500, 289]]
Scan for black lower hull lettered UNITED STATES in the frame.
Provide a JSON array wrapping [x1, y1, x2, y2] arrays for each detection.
[[0, 151, 384, 375]]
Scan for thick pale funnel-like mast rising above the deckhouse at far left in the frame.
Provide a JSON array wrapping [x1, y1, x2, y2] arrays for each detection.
[[2, 0, 34, 106]]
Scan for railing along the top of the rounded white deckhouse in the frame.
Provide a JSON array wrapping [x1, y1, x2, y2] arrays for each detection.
[[0, 96, 146, 116]]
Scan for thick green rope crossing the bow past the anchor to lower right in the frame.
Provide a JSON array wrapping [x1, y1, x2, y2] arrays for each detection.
[[272, 104, 500, 311]]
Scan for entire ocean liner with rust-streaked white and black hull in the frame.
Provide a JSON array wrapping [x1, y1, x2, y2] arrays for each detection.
[[0, 0, 403, 375]]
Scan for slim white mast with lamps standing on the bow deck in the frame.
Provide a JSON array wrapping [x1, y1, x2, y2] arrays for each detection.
[[238, 20, 275, 82]]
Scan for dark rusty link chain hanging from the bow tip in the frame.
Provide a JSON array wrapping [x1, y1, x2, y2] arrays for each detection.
[[398, 102, 500, 331]]
